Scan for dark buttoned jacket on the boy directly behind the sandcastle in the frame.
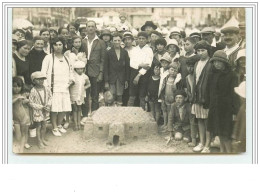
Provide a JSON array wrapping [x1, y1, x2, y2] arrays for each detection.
[[104, 48, 130, 84]]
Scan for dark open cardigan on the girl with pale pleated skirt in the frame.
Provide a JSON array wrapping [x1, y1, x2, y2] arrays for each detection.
[[192, 60, 212, 105]]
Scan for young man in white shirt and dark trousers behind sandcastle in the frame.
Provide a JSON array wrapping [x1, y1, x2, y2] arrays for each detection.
[[128, 31, 153, 109]]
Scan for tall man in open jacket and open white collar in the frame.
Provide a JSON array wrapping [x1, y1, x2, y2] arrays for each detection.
[[82, 20, 106, 121]]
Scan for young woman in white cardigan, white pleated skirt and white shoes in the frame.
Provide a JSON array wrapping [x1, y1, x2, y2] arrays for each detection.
[[42, 37, 74, 136]]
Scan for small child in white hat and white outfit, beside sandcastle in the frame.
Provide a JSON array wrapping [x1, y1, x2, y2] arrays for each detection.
[[70, 60, 90, 131]]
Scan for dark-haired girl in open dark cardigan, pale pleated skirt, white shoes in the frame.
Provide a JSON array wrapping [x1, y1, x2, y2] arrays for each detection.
[[191, 40, 212, 153]]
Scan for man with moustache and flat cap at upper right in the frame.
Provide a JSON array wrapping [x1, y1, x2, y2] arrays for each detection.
[[221, 26, 241, 71]]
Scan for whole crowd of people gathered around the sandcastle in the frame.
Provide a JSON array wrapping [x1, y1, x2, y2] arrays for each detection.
[[12, 14, 246, 153]]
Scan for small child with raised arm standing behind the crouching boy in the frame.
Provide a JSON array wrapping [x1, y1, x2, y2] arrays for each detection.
[[159, 62, 182, 130]]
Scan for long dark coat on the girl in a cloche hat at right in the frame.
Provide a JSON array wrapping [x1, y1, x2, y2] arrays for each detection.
[[204, 67, 239, 138]]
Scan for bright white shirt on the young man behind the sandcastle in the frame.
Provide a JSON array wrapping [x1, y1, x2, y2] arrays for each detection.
[[130, 44, 153, 75]]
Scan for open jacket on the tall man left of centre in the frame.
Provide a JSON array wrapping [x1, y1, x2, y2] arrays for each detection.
[[82, 39, 106, 77]]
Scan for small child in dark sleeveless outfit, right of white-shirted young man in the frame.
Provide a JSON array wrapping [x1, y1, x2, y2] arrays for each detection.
[[148, 66, 161, 124]]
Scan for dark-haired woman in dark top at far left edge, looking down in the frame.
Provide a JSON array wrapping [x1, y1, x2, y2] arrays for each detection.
[[13, 40, 31, 85]]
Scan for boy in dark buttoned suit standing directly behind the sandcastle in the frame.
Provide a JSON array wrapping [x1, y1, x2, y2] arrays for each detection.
[[104, 34, 130, 106]]
